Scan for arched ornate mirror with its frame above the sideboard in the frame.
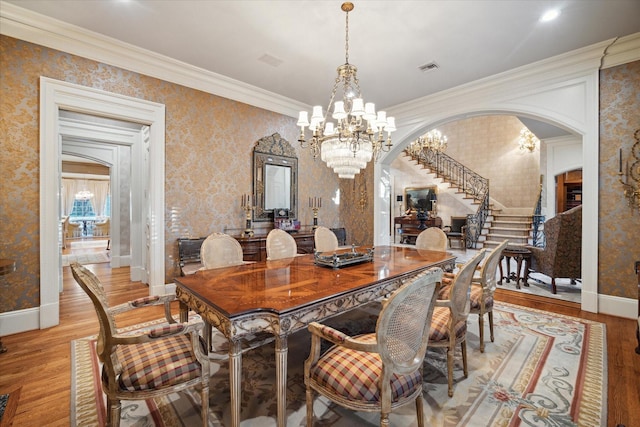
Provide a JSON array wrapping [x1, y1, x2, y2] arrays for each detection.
[[253, 133, 298, 221]]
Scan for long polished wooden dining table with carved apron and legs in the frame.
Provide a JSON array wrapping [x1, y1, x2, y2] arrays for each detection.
[[174, 246, 455, 427]]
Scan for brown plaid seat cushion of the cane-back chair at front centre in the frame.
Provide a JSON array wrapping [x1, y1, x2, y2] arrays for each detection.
[[309, 334, 422, 403]]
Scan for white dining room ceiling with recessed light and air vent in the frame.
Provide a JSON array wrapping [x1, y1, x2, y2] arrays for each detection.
[[7, 0, 640, 137]]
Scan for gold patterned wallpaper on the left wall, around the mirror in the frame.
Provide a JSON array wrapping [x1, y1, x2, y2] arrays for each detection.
[[0, 36, 350, 312]]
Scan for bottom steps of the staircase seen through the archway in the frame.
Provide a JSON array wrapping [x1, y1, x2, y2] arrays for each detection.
[[482, 212, 533, 249]]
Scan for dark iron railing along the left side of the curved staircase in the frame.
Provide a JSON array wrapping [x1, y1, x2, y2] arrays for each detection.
[[405, 144, 490, 248]]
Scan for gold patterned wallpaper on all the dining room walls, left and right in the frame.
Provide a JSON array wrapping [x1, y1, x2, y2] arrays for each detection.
[[0, 36, 640, 312]]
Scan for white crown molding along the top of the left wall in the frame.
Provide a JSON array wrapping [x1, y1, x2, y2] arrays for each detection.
[[0, 1, 310, 118]]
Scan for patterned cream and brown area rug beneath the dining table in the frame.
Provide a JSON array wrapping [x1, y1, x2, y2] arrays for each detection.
[[71, 303, 607, 427]]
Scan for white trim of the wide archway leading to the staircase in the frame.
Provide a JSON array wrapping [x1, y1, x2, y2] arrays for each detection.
[[374, 73, 599, 312]]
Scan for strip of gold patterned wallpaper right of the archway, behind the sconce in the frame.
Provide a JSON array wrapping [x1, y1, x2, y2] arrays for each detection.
[[598, 61, 640, 299]]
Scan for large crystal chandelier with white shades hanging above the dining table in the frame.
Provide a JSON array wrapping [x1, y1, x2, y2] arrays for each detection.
[[297, 2, 396, 179]]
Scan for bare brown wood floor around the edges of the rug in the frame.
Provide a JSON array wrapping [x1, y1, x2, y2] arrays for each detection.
[[0, 256, 640, 427]]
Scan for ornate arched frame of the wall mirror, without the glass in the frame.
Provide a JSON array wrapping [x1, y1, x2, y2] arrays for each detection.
[[253, 133, 298, 222]]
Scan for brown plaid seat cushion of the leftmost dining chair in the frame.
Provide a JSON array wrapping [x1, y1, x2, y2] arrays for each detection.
[[109, 335, 200, 391]]
